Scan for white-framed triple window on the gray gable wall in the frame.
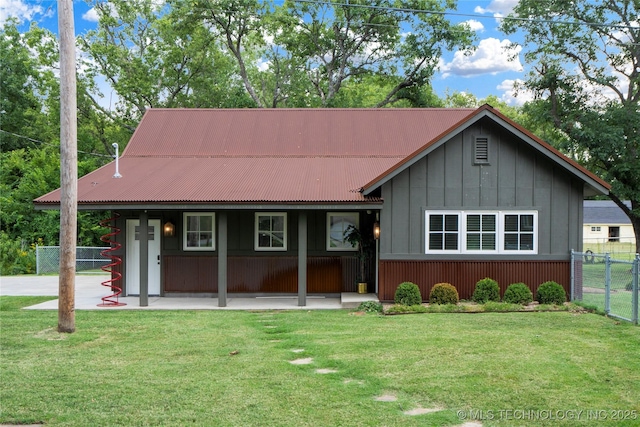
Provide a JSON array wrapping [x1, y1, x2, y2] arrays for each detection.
[[425, 211, 538, 254]]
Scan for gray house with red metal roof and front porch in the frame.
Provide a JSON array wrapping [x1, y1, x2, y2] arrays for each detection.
[[35, 105, 610, 306]]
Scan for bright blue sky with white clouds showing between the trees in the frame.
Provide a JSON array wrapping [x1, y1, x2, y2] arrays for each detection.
[[0, 0, 528, 105]]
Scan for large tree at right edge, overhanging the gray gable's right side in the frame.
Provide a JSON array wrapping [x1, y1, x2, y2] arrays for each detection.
[[502, 0, 640, 252]]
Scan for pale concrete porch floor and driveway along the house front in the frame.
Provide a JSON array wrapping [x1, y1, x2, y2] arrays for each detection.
[[0, 275, 378, 310]]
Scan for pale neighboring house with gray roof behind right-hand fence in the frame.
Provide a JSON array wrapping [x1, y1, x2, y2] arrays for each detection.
[[583, 200, 636, 246]]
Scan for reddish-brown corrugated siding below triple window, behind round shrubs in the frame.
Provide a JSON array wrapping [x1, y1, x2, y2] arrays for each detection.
[[378, 261, 571, 301]]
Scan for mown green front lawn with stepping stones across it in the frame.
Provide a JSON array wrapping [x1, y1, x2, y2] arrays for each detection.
[[0, 297, 640, 427]]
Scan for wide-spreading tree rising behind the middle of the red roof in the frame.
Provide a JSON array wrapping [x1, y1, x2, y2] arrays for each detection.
[[185, 0, 473, 107]]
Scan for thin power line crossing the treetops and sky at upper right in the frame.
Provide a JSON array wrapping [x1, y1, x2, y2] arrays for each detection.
[[293, 0, 640, 30]]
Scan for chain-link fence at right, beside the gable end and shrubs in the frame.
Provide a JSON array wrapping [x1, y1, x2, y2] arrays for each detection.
[[571, 251, 640, 325]]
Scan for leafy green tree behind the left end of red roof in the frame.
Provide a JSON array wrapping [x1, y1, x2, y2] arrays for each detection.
[[80, 0, 247, 123]]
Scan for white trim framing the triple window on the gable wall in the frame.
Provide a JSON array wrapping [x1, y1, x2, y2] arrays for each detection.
[[424, 210, 539, 255]]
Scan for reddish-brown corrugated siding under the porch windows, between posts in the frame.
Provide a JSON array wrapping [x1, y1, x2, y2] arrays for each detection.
[[163, 256, 356, 294]]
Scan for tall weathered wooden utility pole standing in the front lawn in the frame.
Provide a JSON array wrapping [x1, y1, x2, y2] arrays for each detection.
[[58, 0, 78, 333]]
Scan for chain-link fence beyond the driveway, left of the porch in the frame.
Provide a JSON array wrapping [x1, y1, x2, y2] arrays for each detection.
[[36, 246, 111, 274]]
